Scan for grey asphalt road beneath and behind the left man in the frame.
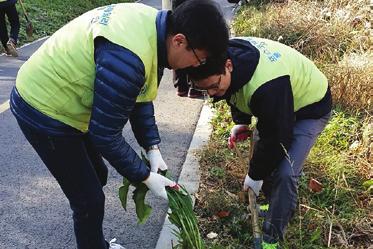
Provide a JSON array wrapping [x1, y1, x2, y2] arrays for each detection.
[[0, 0, 232, 249]]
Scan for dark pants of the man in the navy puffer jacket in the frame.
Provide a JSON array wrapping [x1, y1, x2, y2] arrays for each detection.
[[12, 100, 108, 249]]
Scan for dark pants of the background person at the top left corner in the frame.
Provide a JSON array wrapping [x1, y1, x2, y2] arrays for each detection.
[[0, 4, 20, 48]]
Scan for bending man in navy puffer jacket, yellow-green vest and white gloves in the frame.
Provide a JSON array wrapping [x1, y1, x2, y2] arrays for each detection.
[[10, 0, 228, 249]]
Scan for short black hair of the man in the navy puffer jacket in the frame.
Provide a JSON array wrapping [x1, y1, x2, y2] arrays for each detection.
[[167, 0, 229, 57]]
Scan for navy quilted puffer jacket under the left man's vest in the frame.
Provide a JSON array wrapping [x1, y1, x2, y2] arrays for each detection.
[[11, 11, 168, 182]]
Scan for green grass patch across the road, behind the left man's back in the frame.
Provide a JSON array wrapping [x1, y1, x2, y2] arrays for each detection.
[[1, 0, 131, 50]]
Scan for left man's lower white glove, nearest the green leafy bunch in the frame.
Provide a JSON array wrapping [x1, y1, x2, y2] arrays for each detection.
[[143, 172, 176, 200]]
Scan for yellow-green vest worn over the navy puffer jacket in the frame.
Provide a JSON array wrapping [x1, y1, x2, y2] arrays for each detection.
[[16, 3, 158, 132]]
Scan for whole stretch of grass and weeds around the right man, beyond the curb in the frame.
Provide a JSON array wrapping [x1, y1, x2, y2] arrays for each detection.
[[195, 0, 373, 249]]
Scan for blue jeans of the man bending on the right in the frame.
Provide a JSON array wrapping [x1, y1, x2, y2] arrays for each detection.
[[262, 113, 330, 243]]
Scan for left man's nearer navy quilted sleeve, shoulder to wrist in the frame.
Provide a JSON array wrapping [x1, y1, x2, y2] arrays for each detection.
[[89, 38, 150, 182]]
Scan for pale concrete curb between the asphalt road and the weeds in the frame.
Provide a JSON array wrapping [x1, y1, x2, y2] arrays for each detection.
[[156, 104, 212, 249]]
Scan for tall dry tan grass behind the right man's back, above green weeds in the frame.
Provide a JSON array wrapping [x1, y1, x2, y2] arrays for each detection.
[[233, 0, 373, 112]]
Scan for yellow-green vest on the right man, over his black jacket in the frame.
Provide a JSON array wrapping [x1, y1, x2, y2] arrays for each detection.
[[229, 37, 328, 114]]
